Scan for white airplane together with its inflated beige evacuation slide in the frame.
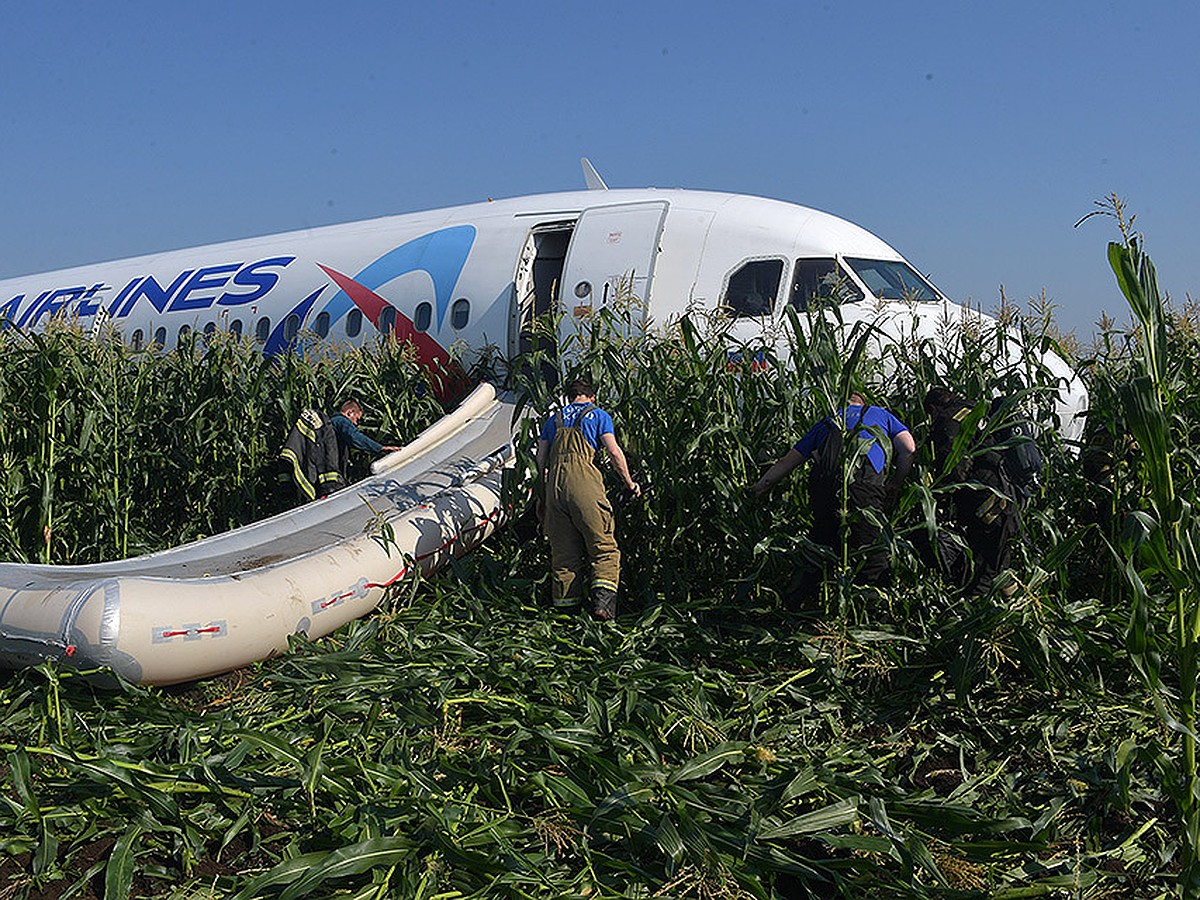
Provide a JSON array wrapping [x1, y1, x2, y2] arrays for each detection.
[[0, 161, 1087, 684]]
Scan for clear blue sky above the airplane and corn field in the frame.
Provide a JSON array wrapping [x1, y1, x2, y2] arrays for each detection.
[[0, 0, 1200, 336]]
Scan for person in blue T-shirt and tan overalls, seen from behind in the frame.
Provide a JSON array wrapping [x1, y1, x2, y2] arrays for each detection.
[[538, 378, 642, 620]]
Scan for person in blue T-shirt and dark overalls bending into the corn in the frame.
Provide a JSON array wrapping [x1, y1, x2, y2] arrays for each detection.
[[750, 392, 917, 606]]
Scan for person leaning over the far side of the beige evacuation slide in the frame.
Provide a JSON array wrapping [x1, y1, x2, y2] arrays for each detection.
[[276, 400, 400, 510]]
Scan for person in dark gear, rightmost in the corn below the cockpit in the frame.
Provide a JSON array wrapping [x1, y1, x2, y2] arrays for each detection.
[[918, 388, 1021, 595]]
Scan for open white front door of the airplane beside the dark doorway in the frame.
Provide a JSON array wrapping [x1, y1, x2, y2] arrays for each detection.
[[559, 200, 667, 353]]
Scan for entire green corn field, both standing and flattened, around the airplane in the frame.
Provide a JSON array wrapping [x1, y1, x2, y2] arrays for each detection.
[[0, 220, 1200, 900]]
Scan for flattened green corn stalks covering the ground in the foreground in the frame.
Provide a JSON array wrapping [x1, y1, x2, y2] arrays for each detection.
[[0, 571, 1144, 898]]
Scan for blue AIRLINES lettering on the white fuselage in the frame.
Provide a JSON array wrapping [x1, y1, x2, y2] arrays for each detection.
[[0, 257, 296, 328]]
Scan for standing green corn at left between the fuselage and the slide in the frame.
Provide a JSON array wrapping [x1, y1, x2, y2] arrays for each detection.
[[0, 324, 442, 563]]
